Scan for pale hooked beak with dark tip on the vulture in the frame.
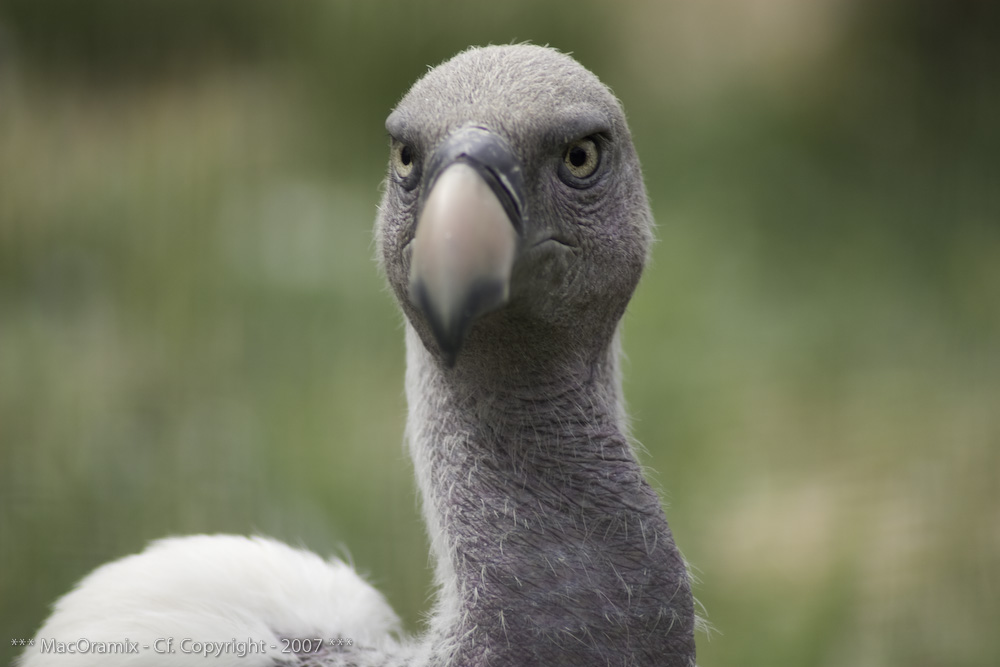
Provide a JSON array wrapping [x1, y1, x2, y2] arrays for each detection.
[[409, 127, 524, 367]]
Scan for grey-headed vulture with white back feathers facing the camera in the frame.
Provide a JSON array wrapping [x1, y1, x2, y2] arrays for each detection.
[[19, 44, 696, 667]]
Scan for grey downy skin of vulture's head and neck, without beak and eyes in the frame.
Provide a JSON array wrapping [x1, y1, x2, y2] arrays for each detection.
[[377, 46, 694, 666]]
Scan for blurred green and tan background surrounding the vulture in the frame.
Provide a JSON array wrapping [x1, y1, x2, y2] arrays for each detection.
[[0, 0, 1000, 667]]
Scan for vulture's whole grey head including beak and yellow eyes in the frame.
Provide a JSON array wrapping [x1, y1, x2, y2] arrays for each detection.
[[377, 45, 652, 369]]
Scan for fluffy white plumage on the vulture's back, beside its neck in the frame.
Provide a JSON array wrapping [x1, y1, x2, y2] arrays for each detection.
[[18, 535, 400, 667]]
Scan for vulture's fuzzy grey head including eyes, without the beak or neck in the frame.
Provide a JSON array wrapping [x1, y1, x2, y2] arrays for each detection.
[[376, 45, 652, 374]]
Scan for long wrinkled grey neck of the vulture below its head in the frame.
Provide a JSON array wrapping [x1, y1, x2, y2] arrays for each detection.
[[406, 330, 694, 667]]
